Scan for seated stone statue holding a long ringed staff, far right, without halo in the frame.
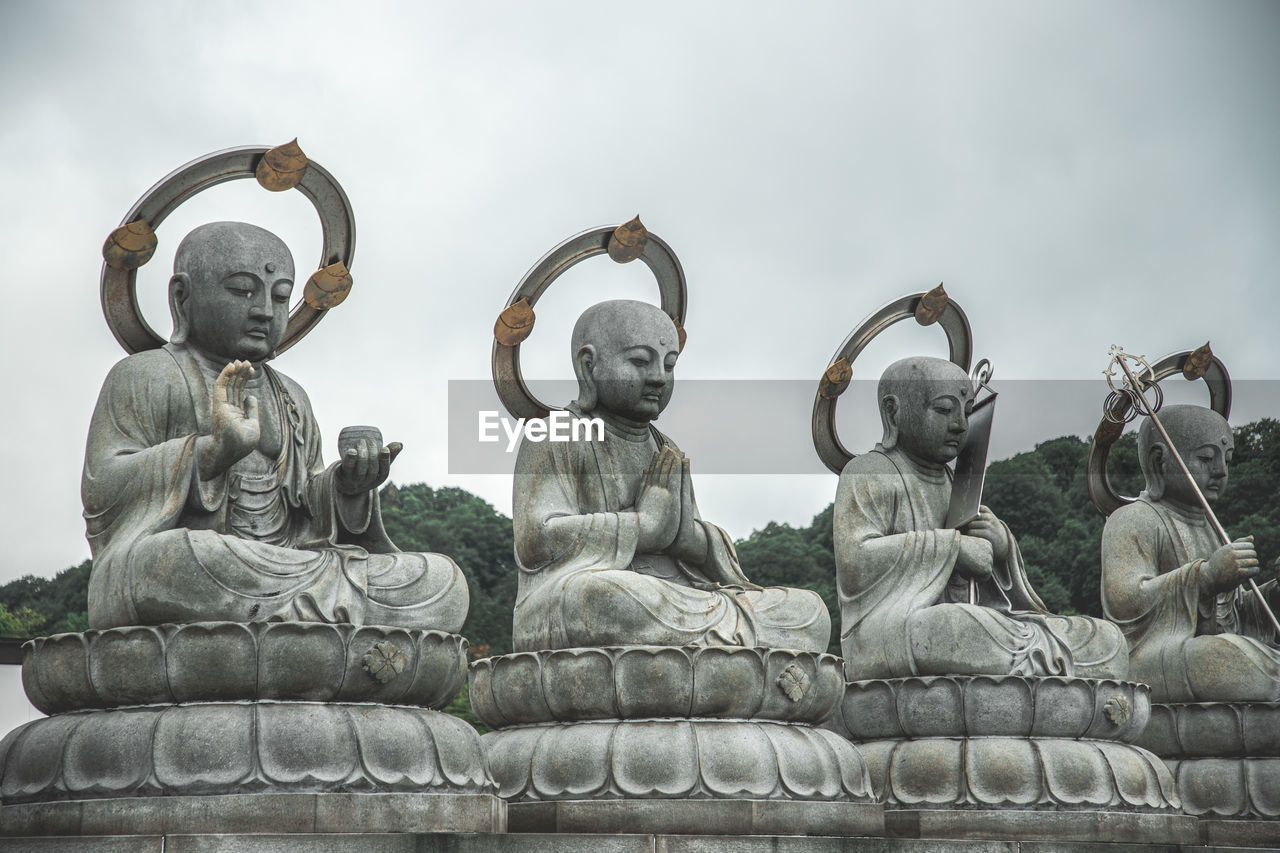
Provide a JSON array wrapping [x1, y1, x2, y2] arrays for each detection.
[[1102, 406, 1280, 702]]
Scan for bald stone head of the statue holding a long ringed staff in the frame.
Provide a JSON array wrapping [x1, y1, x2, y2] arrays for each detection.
[[1138, 406, 1235, 507]]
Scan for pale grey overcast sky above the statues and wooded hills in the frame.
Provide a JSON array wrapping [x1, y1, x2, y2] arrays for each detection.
[[0, 0, 1280, 607]]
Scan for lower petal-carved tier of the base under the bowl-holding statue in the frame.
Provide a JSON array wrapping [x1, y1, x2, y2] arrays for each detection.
[[0, 702, 495, 806]]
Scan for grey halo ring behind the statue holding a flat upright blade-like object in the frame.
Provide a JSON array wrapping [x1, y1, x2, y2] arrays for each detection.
[[813, 293, 973, 474]]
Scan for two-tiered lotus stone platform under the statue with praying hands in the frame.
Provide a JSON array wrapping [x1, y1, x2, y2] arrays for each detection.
[[470, 647, 883, 835]]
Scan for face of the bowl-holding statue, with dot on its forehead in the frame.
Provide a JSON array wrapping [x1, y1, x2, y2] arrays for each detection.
[[184, 238, 293, 361]]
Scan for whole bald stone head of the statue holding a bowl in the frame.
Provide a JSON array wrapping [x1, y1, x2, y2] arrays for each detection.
[[169, 222, 293, 361]]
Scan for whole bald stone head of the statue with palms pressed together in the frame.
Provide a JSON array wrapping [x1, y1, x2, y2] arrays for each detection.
[[572, 300, 680, 424]]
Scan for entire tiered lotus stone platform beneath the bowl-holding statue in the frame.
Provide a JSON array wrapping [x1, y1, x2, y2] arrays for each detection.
[[0, 622, 506, 835]]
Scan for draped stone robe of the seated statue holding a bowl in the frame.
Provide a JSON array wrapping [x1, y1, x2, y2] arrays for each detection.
[[81, 345, 468, 631]]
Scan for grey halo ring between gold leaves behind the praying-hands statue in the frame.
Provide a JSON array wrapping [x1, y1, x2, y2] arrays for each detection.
[[492, 225, 689, 418]]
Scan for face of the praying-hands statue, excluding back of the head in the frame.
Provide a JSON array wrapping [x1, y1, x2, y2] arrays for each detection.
[[591, 309, 680, 423]]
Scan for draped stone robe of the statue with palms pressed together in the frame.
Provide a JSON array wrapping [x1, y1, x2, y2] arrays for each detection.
[[513, 417, 831, 652]]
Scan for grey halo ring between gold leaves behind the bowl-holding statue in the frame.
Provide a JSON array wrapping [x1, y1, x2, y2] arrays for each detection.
[[101, 145, 356, 355]]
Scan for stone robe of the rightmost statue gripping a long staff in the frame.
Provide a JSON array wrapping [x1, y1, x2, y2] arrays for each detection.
[[1102, 492, 1280, 702]]
